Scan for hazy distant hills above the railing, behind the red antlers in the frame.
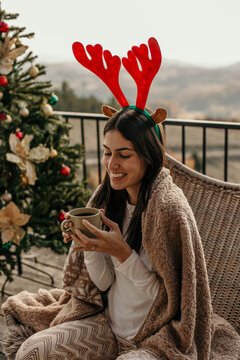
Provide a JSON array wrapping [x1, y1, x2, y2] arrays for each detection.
[[42, 60, 240, 121]]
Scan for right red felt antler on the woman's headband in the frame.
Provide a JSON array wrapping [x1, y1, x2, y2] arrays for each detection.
[[122, 38, 162, 110]]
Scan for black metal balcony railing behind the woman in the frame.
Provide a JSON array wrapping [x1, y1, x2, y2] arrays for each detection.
[[55, 111, 240, 183]]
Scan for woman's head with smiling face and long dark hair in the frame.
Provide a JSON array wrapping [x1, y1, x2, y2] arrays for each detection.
[[90, 109, 165, 252]]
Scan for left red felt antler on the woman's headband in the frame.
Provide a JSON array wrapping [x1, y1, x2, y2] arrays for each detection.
[[72, 42, 129, 107]]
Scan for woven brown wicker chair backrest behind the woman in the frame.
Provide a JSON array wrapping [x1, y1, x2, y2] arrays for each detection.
[[165, 154, 240, 332]]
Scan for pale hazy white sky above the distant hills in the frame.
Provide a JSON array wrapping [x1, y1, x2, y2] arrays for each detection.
[[1, 0, 240, 66]]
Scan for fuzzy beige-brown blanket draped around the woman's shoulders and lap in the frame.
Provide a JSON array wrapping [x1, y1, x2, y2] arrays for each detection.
[[2, 169, 240, 360]]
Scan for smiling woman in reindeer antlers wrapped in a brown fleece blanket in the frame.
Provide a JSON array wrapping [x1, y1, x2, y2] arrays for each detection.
[[3, 38, 240, 360]]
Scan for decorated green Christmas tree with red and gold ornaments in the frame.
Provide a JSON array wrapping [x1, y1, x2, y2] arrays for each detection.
[[0, 3, 87, 279]]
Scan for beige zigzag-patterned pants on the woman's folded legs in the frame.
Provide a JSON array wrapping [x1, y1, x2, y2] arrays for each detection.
[[16, 314, 156, 360]]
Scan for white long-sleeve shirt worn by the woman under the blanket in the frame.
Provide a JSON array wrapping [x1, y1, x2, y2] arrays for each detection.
[[84, 204, 159, 340]]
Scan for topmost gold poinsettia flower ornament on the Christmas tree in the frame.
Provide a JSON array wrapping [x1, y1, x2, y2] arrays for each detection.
[[0, 36, 28, 75]]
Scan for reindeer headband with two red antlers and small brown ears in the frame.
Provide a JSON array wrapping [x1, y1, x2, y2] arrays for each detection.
[[73, 38, 167, 138]]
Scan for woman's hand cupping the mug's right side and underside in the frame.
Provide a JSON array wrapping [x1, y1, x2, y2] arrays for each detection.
[[72, 210, 132, 263]]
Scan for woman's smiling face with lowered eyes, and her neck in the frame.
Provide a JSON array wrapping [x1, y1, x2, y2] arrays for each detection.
[[103, 129, 147, 204]]
